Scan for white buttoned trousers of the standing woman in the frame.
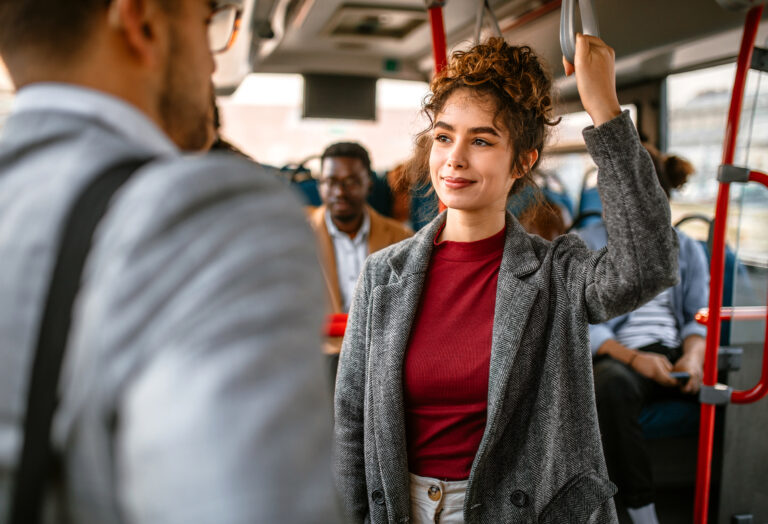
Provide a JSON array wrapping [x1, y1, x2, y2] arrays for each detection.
[[410, 473, 468, 524]]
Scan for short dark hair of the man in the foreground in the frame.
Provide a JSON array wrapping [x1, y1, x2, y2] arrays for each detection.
[[0, 0, 180, 59]]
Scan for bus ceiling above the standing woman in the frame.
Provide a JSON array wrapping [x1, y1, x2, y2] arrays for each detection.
[[214, 0, 768, 100]]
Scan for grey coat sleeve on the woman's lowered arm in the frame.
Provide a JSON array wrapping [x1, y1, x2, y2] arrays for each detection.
[[333, 257, 371, 522]]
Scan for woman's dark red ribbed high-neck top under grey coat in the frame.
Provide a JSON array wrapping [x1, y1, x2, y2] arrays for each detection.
[[403, 225, 505, 480]]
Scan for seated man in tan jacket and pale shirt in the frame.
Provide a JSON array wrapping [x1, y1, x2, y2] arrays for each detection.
[[309, 142, 413, 379]]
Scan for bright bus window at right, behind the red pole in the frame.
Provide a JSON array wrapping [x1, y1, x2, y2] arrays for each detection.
[[666, 64, 768, 264]]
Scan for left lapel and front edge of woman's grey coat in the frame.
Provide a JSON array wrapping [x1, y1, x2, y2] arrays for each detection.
[[368, 214, 444, 511]]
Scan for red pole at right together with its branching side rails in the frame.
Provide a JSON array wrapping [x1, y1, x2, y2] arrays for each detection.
[[693, 5, 768, 524]]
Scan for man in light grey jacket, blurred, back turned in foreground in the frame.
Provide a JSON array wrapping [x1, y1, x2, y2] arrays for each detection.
[[0, 0, 336, 524]]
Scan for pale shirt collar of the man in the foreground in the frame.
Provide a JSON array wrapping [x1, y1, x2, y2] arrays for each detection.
[[12, 82, 180, 156]]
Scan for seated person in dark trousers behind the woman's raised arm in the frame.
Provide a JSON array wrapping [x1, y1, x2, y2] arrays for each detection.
[[579, 146, 709, 523]]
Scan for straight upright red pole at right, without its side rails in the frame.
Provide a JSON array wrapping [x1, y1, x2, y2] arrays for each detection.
[[693, 5, 763, 524]]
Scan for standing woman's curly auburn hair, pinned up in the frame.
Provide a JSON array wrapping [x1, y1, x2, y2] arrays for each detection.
[[408, 37, 560, 195]]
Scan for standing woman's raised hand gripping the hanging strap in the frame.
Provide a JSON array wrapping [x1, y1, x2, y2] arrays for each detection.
[[563, 33, 621, 127]]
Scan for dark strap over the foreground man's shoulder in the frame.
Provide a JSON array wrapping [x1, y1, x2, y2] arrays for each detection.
[[8, 159, 149, 524]]
